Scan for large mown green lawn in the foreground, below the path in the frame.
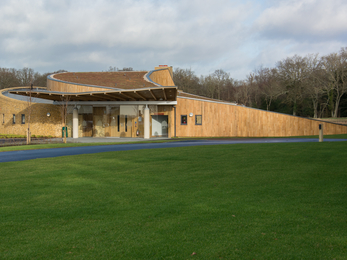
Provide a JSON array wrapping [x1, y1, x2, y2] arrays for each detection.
[[0, 142, 347, 259]]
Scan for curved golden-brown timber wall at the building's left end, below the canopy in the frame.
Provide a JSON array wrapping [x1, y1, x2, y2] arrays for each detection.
[[0, 89, 62, 136]]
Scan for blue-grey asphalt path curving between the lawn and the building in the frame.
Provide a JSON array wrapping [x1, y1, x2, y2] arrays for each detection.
[[0, 138, 347, 163]]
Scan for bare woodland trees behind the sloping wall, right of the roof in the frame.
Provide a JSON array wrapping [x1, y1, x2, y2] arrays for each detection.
[[173, 47, 347, 118]]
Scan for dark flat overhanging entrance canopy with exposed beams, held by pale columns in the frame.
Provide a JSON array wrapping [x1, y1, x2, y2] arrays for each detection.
[[9, 86, 177, 102]]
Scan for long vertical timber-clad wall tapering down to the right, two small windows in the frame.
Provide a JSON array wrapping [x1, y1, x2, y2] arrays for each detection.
[[176, 97, 347, 137]]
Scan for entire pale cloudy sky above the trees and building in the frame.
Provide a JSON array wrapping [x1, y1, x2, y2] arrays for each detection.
[[0, 0, 347, 80]]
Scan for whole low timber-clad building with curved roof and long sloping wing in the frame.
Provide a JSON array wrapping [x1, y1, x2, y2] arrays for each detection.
[[0, 66, 347, 138]]
